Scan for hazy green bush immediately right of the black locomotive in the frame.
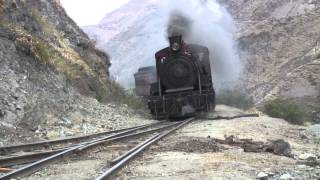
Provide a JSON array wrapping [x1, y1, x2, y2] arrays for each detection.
[[216, 89, 254, 110]]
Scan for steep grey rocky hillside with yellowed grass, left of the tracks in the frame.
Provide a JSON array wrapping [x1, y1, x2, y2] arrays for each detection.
[[0, 0, 148, 144]]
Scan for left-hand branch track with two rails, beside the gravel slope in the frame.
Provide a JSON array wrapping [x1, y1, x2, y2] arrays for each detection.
[[0, 121, 168, 167]]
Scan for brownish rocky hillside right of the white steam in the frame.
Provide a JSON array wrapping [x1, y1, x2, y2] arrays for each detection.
[[221, 0, 320, 121]]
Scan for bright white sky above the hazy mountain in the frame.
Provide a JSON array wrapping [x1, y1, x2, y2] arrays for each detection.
[[60, 0, 129, 26]]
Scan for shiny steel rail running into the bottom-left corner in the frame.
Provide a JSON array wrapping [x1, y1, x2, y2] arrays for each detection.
[[0, 122, 180, 180]]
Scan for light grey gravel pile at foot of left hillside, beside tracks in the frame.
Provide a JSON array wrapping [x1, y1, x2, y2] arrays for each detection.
[[35, 96, 153, 139]]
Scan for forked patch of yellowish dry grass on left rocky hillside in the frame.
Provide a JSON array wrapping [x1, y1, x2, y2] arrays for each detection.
[[0, 8, 97, 79]]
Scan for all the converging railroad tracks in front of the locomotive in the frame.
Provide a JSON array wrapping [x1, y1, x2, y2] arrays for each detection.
[[0, 118, 194, 179]]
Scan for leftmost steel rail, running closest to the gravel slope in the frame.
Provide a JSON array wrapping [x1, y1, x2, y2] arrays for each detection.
[[0, 121, 168, 155]]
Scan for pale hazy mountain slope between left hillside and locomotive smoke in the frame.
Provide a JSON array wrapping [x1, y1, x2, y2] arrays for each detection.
[[83, 0, 167, 86]]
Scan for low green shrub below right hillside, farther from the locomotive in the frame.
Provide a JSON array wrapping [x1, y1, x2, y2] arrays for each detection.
[[263, 99, 305, 125]]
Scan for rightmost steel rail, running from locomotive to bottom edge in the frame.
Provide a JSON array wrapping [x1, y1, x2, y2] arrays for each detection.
[[95, 118, 194, 180]]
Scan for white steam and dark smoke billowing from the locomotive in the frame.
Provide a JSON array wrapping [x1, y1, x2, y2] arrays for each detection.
[[162, 0, 243, 89]]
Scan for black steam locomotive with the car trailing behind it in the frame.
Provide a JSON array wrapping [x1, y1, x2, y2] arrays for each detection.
[[134, 36, 215, 120]]
